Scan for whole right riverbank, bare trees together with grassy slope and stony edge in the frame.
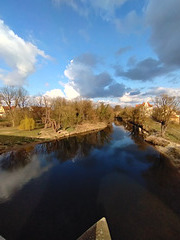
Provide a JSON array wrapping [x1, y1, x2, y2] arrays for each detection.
[[115, 95, 180, 168]]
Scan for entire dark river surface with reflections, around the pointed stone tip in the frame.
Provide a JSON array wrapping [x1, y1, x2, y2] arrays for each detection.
[[0, 125, 180, 240]]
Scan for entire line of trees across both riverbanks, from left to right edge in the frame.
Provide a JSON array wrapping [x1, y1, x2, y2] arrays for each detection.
[[0, 86, 180, 136]]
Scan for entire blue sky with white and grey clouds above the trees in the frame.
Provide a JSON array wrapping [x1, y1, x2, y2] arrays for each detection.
[[0, 0, 180, 105]]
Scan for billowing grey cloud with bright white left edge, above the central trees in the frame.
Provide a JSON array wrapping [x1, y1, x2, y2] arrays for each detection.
[[64, 54, 126, 98]]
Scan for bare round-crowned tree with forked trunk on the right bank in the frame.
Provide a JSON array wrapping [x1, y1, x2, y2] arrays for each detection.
[[152, 94, 179, 137]]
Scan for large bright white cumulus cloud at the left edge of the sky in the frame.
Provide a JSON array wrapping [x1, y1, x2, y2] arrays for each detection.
[[0, 20, 50, 85]]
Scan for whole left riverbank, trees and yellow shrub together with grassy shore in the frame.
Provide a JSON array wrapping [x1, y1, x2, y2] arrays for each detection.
[[0, 86, 114, 152]]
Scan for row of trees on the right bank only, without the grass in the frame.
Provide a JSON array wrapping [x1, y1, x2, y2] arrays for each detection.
[[115, 94, 180, 137]]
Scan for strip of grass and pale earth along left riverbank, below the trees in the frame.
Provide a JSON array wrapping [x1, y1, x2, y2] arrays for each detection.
[[0, 122, 107, 154]]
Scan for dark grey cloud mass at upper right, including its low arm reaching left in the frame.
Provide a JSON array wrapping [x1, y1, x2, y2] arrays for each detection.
[[115, 0, 180, 81]]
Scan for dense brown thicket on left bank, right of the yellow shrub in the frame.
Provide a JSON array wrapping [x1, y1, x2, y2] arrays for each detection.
[[43, 97, 114, 131]]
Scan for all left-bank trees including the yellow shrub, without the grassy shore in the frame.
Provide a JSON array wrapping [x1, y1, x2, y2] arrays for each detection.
[[0, 87, 114, 131]]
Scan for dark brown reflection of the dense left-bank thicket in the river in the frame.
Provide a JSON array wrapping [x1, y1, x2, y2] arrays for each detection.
[[34, 126, 112, 162]]
